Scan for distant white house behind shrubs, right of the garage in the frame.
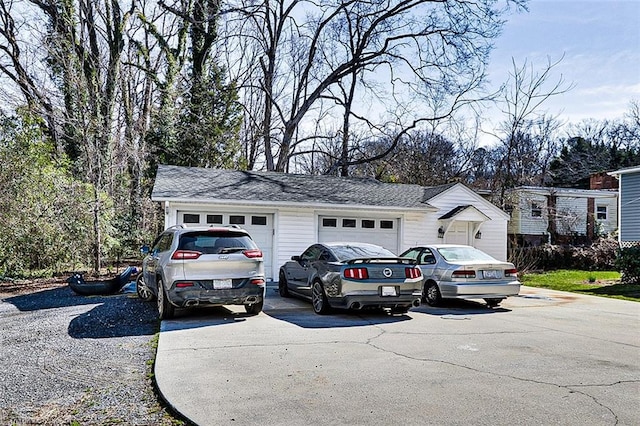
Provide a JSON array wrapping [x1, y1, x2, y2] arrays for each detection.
[[507, 186, 618, 245]]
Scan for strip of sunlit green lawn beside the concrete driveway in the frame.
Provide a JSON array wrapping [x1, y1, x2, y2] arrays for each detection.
[[520, 270, 640, 302]]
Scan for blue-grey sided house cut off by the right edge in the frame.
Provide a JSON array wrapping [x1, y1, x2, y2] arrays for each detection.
[[609, 165, 640, 247]]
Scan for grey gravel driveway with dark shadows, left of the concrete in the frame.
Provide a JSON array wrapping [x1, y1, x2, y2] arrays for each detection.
[[0, 284, 184, 425]]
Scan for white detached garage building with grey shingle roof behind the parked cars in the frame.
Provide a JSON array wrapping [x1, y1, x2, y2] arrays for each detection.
[[151, 165, 509, 279]]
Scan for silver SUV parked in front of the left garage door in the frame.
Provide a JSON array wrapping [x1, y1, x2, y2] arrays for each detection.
[[138, 225, 265, 319]]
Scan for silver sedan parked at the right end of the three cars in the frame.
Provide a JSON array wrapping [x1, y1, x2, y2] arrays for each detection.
[[400, 244, 520, 307]]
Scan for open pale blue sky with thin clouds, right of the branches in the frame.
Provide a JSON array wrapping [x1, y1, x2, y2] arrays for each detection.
[[488, 0, 640, 136]]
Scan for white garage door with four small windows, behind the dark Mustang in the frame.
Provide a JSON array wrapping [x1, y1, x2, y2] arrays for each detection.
[[318, 216, 400, 254]]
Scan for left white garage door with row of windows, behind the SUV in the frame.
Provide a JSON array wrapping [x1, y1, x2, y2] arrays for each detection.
[[177, 210, 273, 279]]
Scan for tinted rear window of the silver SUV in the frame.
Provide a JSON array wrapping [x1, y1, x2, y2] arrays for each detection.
[[178, 231, 258, 254]]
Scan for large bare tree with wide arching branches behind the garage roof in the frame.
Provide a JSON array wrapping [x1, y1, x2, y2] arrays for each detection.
[[226, 0, 525, 174]]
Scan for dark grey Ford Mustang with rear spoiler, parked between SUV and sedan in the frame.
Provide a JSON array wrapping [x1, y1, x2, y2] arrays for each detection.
[[278, 243, 422, 314]]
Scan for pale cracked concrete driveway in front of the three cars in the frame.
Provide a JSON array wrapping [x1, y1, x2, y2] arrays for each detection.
[[155, 287, 640, 426]]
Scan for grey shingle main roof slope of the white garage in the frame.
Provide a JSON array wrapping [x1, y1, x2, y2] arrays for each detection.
[[151, 165, 454, 208]]
